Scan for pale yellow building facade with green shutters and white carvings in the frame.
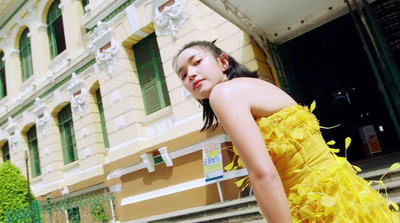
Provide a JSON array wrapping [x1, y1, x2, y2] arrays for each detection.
[[0, 0, 275, 222]]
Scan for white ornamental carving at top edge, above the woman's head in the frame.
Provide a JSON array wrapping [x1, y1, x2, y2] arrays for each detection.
[[154, 2, 189, 37]]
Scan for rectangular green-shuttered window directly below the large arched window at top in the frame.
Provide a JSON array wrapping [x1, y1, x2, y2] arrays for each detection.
[[58, 104, 78, 164]]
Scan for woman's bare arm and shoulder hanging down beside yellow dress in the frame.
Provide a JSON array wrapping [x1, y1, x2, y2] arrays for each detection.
[[210, 82, 292, 223]]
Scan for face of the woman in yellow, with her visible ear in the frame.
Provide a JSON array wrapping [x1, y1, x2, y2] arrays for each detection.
[[176, 46, 229, 99]]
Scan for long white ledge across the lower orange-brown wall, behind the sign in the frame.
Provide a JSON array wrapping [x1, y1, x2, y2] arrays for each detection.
[[121, 169, 248, 206]]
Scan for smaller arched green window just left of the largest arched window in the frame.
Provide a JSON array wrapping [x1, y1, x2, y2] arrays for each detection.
[[19, 28, 33, 81]]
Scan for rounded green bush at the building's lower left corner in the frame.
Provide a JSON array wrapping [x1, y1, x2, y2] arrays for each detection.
[[0, 161, 34, 222]]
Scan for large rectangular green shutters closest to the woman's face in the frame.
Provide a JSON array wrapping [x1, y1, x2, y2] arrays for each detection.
[[133, 34, 171, 114]]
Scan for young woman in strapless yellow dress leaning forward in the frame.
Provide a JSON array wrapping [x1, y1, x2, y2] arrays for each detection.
[[174, 41, 398, 223]]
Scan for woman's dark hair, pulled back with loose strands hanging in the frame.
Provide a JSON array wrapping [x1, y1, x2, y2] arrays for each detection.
[[172, 40, 259, 132]]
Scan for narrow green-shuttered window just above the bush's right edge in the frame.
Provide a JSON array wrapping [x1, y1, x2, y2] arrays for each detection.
[[27, 125, 41, 177]]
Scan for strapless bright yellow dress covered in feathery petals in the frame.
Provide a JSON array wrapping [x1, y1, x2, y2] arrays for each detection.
[[230, 105, 400, 223]]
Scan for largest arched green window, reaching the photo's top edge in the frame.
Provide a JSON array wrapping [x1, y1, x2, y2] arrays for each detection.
[[47, 0, 66, 59]]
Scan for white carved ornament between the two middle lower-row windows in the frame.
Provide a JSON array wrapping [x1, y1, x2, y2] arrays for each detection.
[[68, 72, 89, 115]]
